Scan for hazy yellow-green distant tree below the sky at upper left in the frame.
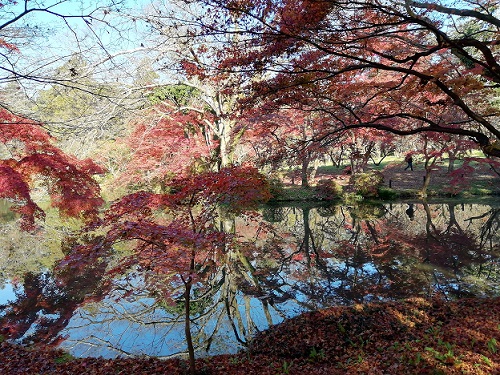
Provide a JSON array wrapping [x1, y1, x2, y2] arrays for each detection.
[[31, 54, 134, 157]]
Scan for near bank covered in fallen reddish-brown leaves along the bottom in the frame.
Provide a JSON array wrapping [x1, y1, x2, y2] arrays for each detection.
[[0, 298, 500, 375]]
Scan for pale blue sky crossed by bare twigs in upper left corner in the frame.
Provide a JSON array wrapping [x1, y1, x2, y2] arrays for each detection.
[[0, 0, 150, 86]]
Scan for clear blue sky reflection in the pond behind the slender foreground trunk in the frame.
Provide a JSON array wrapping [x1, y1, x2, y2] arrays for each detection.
[[61, 293, 294, 358]]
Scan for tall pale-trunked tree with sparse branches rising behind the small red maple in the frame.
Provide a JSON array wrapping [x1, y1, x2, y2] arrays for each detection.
[[129, 1, 262, 169]]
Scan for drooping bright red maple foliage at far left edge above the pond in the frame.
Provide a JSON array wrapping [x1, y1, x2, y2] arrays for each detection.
[[0, 109, 104, 229]]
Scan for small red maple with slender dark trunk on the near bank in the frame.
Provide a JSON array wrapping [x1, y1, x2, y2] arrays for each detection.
[[68, 166, 269, 374]]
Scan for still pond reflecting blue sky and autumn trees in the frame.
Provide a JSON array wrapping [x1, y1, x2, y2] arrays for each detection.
[[0, 200, 500, 358]]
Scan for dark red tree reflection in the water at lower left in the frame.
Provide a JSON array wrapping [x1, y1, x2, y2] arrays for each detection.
[[0, 239, 108, 345]]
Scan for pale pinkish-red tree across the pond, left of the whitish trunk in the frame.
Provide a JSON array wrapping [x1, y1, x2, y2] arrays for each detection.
[[114, 85, 218, 193]]
